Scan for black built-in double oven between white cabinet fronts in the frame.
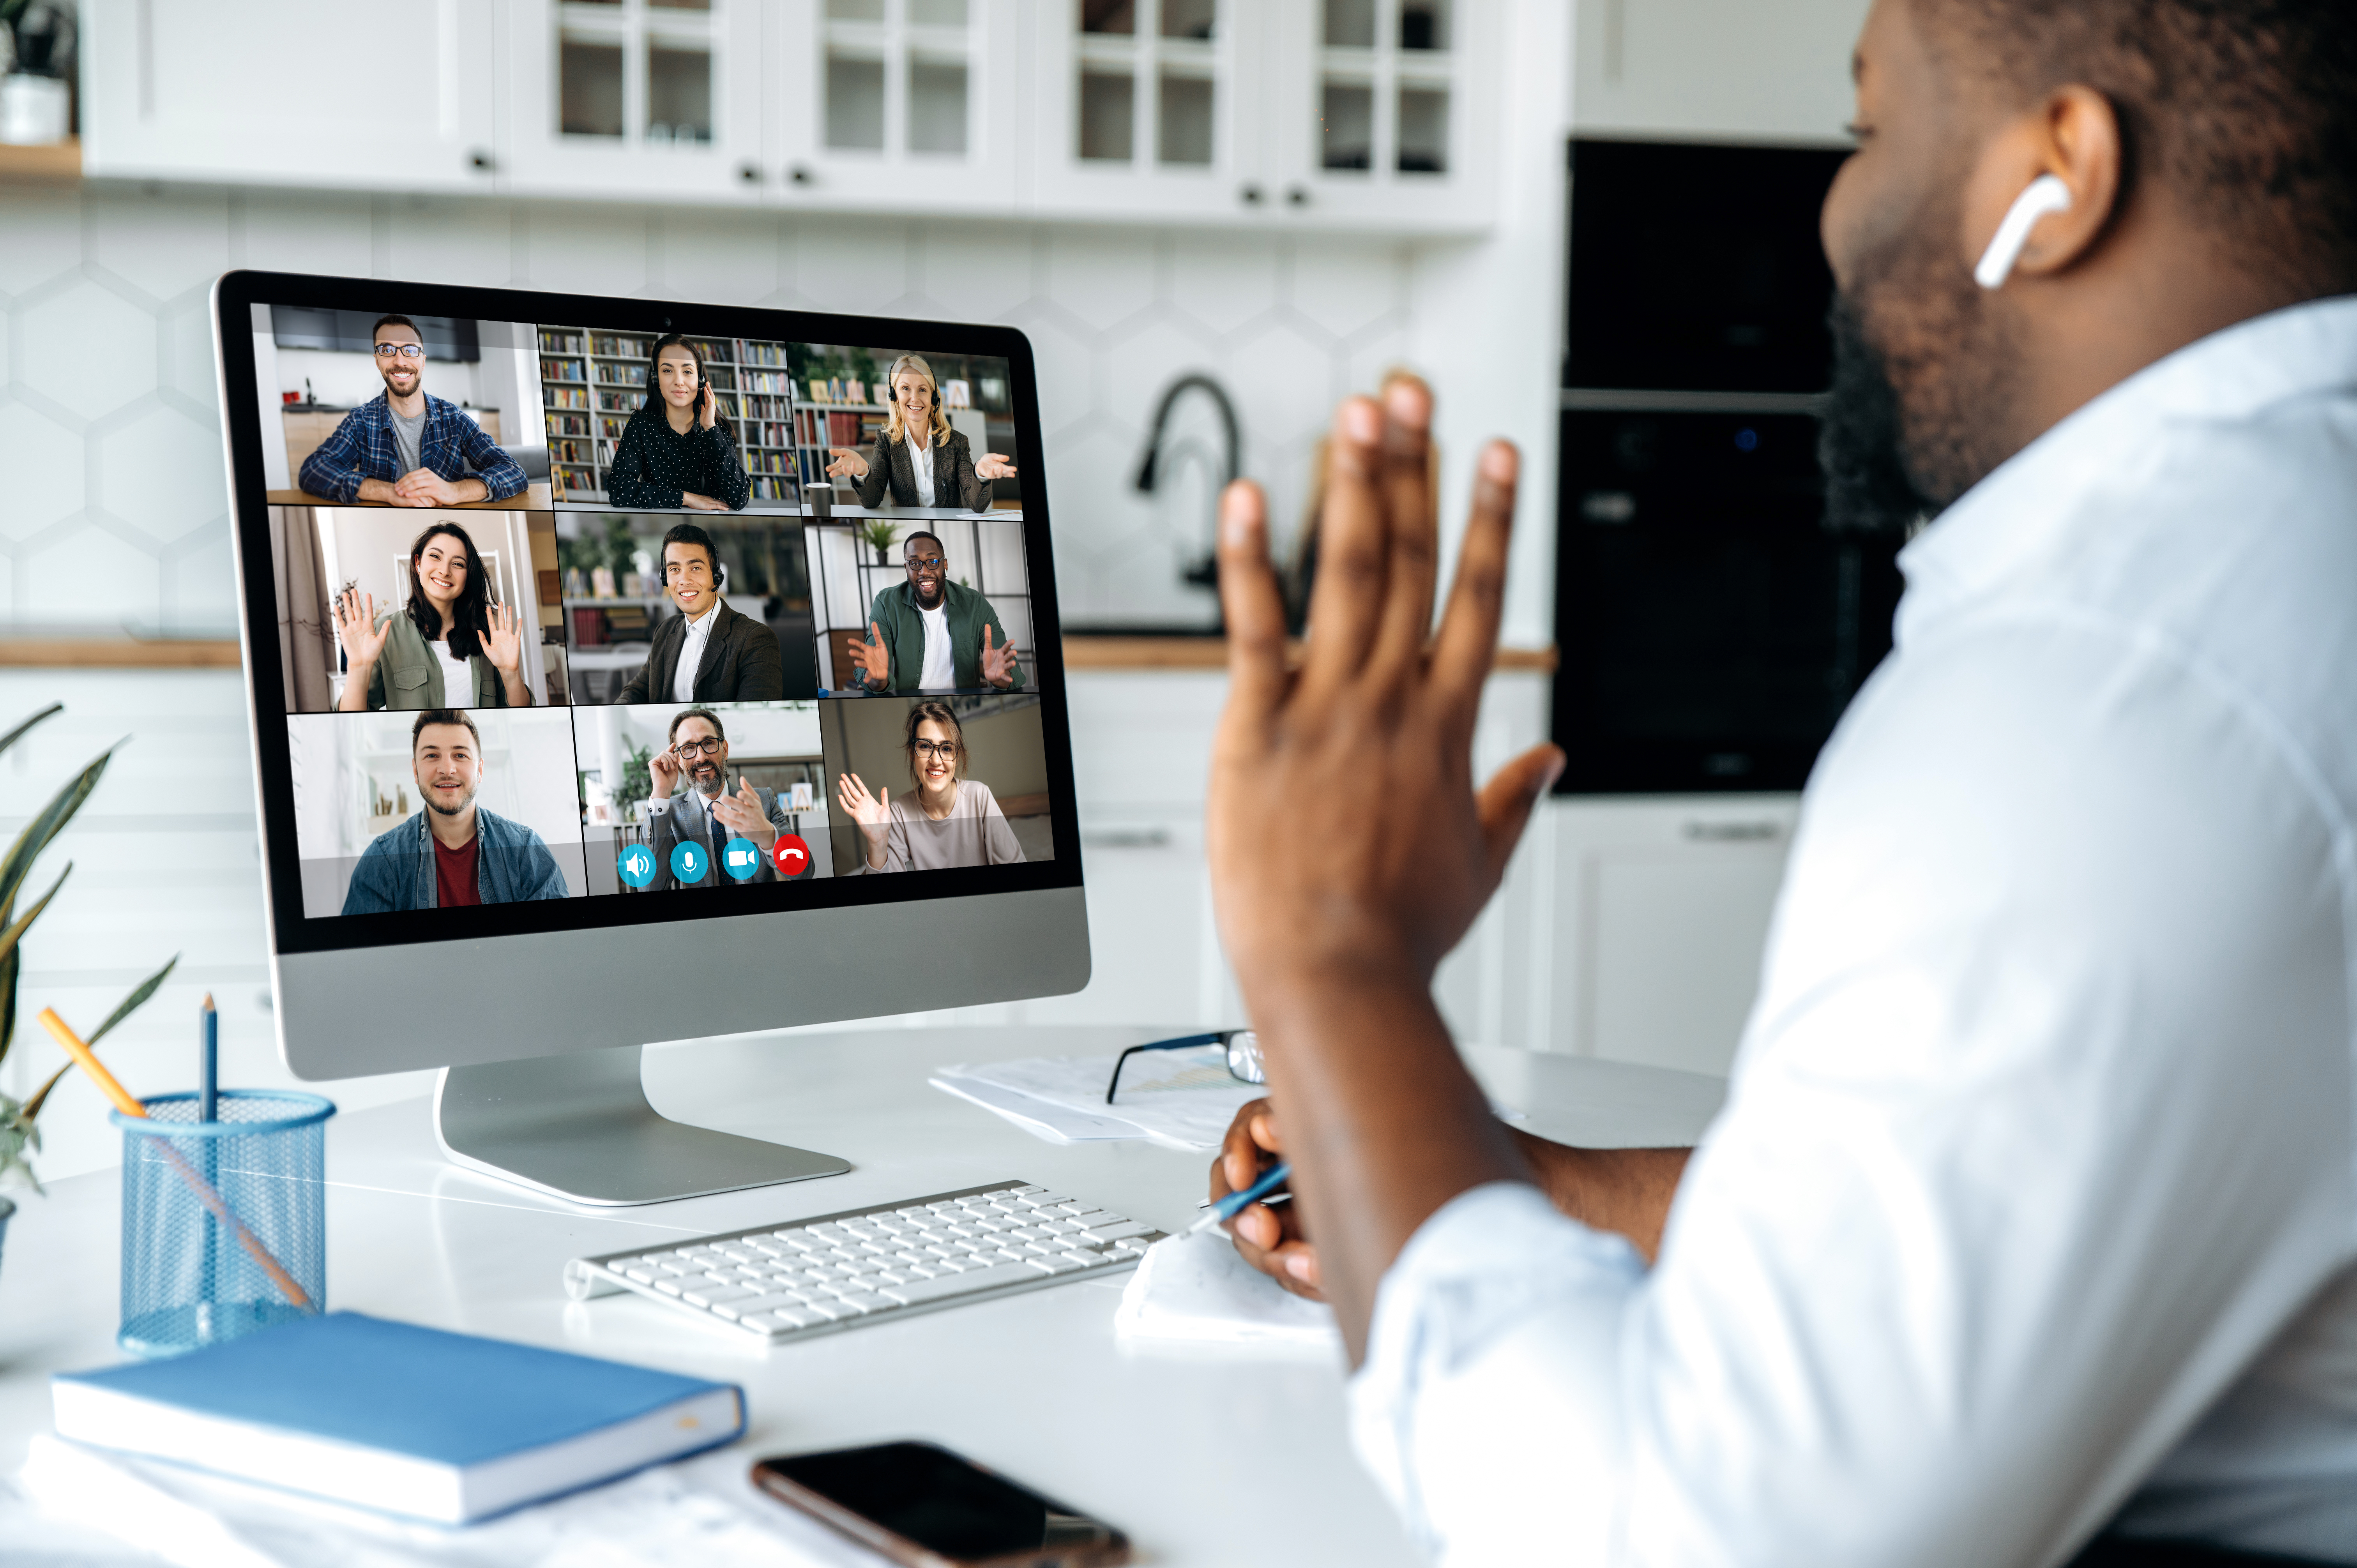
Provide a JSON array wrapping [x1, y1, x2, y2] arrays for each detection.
[[1553, 139, 1900, 795]]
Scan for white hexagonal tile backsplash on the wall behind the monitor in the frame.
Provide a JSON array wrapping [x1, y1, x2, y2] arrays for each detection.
[[0, 186, 1410, 634]]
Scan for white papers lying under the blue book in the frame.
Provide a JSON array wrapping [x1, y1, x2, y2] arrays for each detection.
[[0, 1434, 882, 1568]]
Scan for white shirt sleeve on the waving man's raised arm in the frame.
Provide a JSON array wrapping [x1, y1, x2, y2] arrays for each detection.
[[1353, 611, 2357, 1568]]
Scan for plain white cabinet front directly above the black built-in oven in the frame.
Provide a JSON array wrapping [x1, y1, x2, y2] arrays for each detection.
[[1572, 0, 1869, 146]]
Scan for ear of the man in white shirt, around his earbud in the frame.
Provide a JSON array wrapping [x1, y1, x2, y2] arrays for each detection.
[[1961, 85, 2126, 278]]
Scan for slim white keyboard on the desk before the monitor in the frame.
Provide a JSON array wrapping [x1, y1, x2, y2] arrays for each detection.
[[566, 1181, 1162, 1339]]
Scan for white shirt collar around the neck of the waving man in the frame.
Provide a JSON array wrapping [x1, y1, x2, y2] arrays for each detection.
[[1898, 297, 2357, 641]]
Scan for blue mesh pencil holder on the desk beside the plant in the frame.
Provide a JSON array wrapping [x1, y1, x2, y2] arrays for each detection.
[[113, 1089, 335, 1356]]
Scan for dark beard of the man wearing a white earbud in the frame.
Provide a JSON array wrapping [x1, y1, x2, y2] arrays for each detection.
[[1817, 199, 2015, 533]]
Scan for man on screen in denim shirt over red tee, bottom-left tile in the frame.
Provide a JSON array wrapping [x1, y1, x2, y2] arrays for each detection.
[[344, 707, 566, 915]]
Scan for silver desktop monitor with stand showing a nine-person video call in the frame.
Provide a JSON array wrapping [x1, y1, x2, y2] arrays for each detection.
[[212, 271, 1089, 1205]]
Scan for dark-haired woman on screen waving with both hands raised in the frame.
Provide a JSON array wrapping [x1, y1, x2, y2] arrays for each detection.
[[335, 521, 537, 712]]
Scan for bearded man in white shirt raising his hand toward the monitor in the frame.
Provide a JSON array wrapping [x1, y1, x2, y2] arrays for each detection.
[[1207, 0, 2357, 1568]]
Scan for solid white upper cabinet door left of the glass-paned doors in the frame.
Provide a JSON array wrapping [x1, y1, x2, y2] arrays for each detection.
[[80, 0, 500, 193]]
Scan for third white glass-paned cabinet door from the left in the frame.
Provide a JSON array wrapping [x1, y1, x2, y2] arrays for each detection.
[[1030, 0, 1266, 217]]
